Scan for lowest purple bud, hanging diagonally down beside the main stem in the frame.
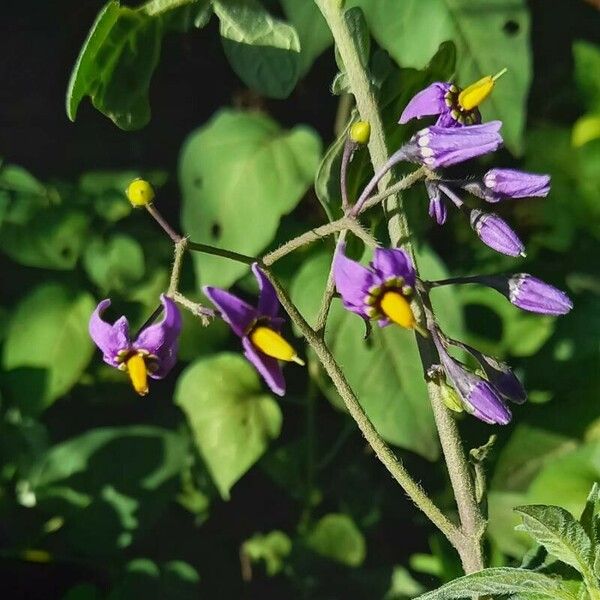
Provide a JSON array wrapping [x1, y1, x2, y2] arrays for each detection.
[[436, 344, 512, 425]]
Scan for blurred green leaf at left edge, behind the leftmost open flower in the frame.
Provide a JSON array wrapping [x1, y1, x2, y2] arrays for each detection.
[[2, 283, 95, 407]]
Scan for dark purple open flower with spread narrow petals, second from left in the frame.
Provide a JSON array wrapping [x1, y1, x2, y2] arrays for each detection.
[[202, 263, 304, 396]]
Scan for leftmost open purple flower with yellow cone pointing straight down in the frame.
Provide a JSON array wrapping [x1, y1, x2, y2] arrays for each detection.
[[89, 294, 181, 396]]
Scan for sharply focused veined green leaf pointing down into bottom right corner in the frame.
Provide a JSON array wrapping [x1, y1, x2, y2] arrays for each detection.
[[515, 505, 593, 581]]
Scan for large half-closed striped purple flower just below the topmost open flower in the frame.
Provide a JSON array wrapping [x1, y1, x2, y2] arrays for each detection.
[[401, 121, 502, 169]]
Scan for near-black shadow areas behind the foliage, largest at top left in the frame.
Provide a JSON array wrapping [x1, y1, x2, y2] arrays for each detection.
[[0, 0, 599, 599]]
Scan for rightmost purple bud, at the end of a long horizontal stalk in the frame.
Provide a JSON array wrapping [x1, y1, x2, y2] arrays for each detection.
[[508, 273, 573, 316]]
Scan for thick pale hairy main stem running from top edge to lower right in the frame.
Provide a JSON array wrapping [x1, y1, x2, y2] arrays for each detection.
[[315, 0, 484, 573]]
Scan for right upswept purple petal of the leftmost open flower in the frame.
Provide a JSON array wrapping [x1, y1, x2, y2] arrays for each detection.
[[132, 294, 181, 379]]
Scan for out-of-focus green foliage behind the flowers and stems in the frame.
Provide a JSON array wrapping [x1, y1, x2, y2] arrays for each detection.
[[0, 0, 600, 600]]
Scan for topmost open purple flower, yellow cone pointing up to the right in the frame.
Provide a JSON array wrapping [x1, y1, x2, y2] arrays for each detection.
[[399, 69, 506, 127]]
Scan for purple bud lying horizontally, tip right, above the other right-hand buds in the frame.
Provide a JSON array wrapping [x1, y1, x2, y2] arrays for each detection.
[[463, 169, 550, 202]]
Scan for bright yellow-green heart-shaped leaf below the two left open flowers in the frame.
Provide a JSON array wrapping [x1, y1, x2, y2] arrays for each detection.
[[175, 353, 282, 500]]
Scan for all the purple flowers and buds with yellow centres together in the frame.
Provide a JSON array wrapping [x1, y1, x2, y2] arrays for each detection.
[[89, 74, 572, 432]]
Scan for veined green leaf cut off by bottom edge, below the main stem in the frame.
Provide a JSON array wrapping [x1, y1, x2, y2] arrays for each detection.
[[417, 567, 575, 600]]
